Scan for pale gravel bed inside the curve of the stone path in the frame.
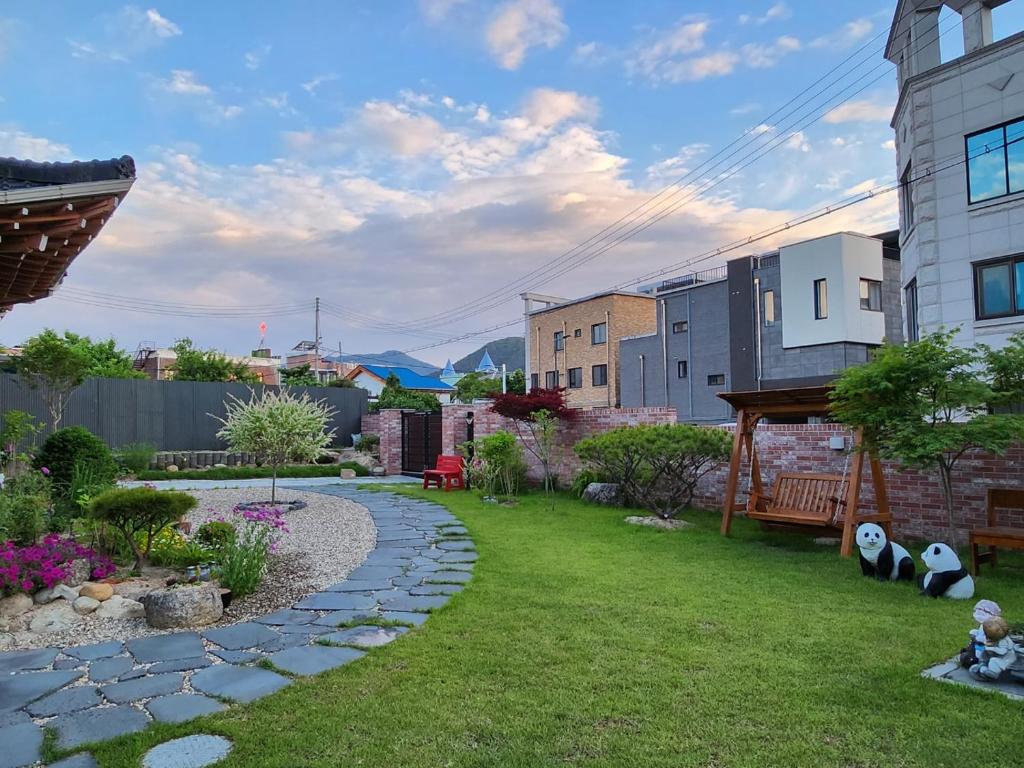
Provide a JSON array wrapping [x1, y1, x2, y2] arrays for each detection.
[[0, 487, 377, 650]]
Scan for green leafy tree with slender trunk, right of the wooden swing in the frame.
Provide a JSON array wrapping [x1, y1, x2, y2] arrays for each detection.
[[830, 331, 1024, 539]]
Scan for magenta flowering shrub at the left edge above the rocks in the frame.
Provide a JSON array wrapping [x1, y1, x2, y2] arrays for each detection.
[[0, 534, 115, 595]]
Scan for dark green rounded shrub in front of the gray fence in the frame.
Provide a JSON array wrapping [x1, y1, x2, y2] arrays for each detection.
[[32, 427, 118, 516]]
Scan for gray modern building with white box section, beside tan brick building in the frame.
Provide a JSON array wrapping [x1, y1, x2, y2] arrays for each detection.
[[620, 232, 903, 423]]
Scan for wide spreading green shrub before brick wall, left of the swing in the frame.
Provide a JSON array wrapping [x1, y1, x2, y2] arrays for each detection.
[[575, 424, 732, 519]]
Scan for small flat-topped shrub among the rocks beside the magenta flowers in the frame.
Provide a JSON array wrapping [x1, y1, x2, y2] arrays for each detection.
[[89, 486, 196, 570]]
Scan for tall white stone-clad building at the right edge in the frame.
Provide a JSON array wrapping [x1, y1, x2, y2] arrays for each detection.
[[886, 0, 1024, 347]]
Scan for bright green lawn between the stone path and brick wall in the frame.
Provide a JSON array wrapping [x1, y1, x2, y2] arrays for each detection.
[[81, 489, 1024, 768]]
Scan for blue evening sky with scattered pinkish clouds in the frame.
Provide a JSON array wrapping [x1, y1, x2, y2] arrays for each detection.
[[0, 0, 1024, 365]]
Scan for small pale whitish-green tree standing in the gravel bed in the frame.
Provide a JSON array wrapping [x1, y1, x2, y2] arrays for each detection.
[[214, 389, 335, 503]]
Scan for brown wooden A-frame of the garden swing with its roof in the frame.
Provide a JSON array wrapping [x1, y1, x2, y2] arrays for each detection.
[[718, 386, 892, 557]]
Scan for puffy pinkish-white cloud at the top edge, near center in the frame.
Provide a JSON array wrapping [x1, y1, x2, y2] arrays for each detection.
[[486, 0, 568, 70]]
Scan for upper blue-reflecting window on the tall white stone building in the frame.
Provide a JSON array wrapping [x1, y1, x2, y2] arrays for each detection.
[[966, 119, 1024, 203]]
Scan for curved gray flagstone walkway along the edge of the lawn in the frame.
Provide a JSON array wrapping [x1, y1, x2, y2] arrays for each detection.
[[0, 485, 476, 768]]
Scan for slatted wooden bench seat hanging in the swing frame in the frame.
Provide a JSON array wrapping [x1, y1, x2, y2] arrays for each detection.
[[746, 472, 845, 527]]
